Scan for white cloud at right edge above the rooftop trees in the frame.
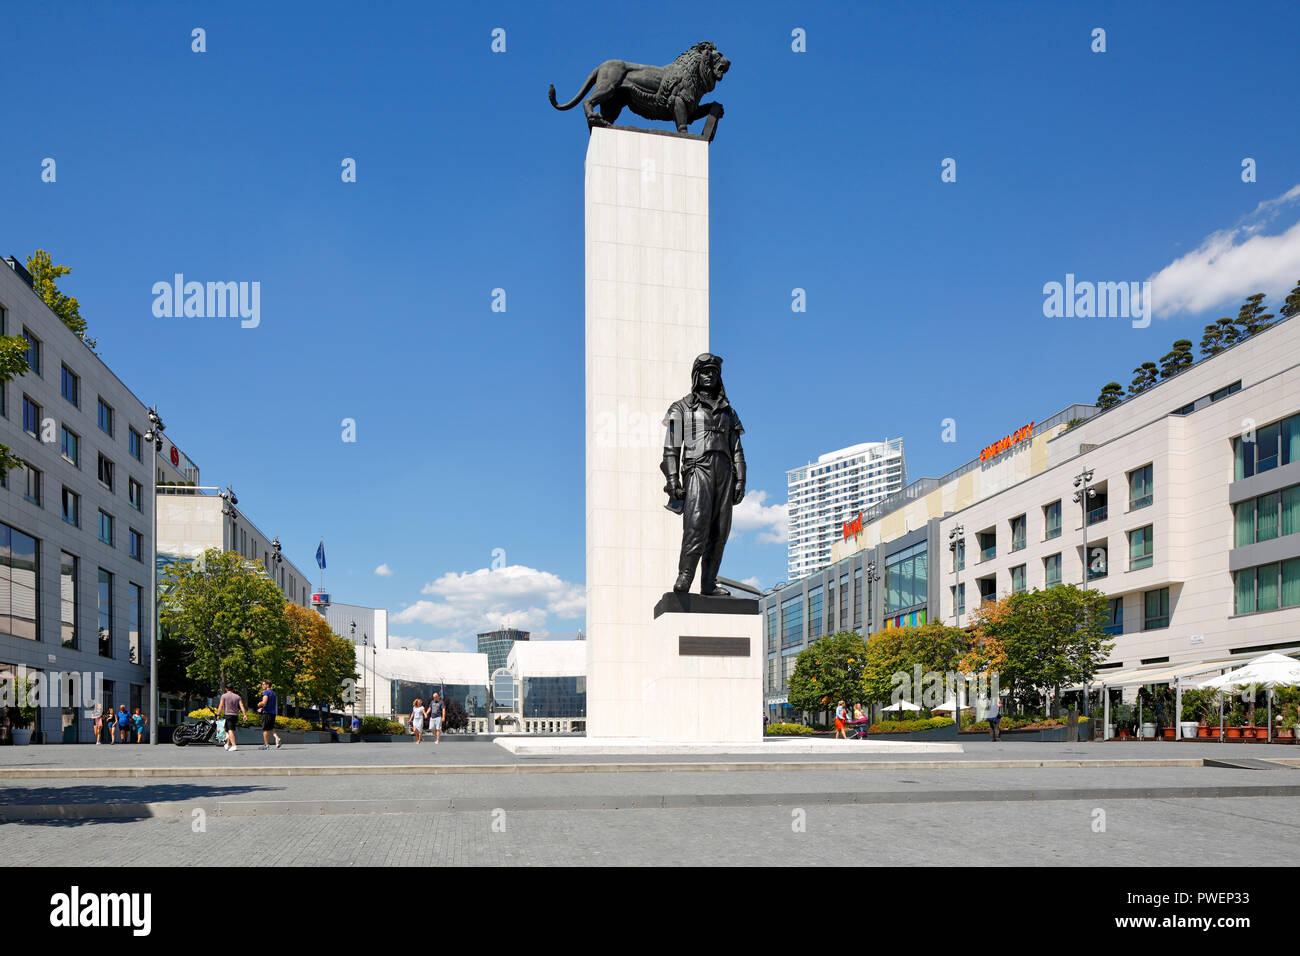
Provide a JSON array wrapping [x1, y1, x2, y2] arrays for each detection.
[[1151, 185, 1300, 319]]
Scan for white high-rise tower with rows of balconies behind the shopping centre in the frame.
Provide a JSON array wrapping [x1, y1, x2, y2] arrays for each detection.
[[785, 438, 907, 581]]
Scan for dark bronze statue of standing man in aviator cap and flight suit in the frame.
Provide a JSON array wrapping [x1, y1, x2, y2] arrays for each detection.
[[660, 352, 745, 597]]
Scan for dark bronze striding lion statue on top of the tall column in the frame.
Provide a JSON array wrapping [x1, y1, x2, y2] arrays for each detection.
[[550, 40, 731, 133]]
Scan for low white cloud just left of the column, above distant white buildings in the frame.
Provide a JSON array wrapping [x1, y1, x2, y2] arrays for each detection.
[[393, 564, 586, 633]]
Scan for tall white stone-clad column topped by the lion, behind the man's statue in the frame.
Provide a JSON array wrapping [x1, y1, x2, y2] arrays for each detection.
[[585, 129, 712, 737]]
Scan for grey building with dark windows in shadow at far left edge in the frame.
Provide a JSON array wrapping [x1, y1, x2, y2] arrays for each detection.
[[0, 252, 153, 743]]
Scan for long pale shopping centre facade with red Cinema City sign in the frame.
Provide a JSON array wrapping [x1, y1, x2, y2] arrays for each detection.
[[762, 320, 1300, 719]]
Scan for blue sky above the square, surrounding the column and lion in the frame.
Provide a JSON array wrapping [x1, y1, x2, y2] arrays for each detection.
[[0, 0, 1300, 648]]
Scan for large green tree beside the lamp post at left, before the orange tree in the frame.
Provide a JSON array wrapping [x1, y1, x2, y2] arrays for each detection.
[[159, 548, 293, 696]]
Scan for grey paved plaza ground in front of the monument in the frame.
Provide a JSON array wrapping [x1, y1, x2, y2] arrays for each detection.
[[0, 741, 1300, 866]]
